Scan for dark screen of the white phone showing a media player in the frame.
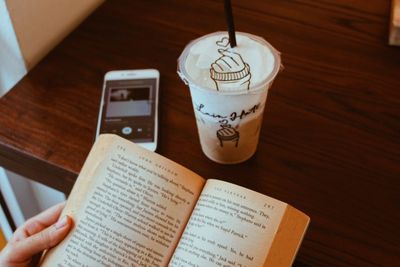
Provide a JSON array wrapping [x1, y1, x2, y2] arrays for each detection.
[[100, 79, 157, 143]]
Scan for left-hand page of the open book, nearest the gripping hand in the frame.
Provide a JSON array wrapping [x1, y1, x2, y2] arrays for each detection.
[[42, 135, 204, 266]]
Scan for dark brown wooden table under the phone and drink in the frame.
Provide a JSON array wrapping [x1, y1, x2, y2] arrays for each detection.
[[0, 0, 400, 266]]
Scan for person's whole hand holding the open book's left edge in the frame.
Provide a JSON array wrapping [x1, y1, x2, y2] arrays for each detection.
[[0, 203, 72, 267]]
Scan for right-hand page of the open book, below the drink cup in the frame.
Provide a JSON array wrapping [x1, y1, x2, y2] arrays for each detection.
[[169, 180, 287, 267]]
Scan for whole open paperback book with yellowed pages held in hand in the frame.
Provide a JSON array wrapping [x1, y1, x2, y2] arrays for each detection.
[[41, 134, 309, 267]]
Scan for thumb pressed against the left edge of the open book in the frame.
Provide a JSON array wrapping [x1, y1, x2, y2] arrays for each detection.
[[13, 216, 72, 259]]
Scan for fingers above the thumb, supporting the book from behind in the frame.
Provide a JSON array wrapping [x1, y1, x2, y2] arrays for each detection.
[[12, 202, 65, 242]]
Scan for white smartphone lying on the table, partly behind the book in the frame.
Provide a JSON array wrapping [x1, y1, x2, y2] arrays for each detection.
[[96, 69, 160, 151]]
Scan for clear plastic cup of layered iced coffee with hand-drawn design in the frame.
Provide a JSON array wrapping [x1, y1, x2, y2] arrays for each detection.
[[178, 32, 281, 164]]
